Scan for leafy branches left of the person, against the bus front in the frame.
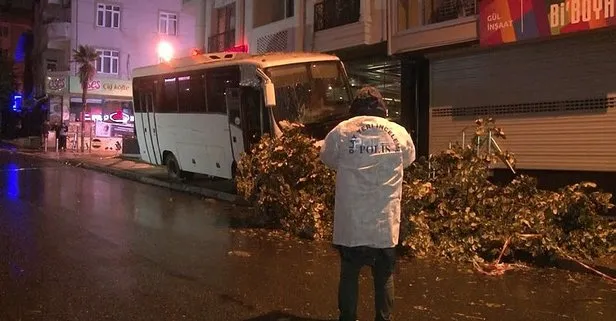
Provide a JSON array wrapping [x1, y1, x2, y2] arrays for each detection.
[[236, 123, 335, 239]]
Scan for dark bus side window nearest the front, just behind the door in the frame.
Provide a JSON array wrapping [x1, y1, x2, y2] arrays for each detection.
[[205, 67, 240, 113]]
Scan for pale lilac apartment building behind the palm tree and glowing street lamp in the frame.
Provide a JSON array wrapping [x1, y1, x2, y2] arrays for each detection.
[[35, 0, 195, 149]]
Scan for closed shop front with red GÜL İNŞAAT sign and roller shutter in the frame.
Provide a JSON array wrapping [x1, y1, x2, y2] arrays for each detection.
[[427, 0, 616, 171]]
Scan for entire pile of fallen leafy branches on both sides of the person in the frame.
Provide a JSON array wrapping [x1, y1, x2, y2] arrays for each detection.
[[237, 119, 616, 262]]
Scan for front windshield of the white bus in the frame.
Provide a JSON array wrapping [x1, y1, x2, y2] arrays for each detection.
[[265, 61, 351, 124]]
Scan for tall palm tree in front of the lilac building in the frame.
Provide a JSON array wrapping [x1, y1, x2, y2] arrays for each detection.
[[73, 45, 99, 152]]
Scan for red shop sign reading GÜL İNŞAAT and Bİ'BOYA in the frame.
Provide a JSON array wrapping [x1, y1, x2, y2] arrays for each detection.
[[479, 0, 616, 46]]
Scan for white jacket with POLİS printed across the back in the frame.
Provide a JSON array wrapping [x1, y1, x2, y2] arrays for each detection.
[[321, 116, 415, 248]]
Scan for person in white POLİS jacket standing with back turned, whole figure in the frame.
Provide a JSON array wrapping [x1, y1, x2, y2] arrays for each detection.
[[320, 87, 415, 321]]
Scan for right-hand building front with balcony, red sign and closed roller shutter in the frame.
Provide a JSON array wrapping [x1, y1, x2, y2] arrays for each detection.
[[390, 0, 616, 172]]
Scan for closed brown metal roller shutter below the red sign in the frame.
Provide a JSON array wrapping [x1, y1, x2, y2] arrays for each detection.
[[430, 30, 616, 171]]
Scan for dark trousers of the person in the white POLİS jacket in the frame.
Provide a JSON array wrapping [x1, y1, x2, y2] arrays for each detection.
[[337, 246, 396, 321]]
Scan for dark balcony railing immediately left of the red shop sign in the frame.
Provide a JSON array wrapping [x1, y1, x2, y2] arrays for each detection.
[[423, 0, 477, 25]]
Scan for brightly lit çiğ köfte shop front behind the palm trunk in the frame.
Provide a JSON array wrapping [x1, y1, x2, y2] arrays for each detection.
[[47, 74, 135, 152]]
